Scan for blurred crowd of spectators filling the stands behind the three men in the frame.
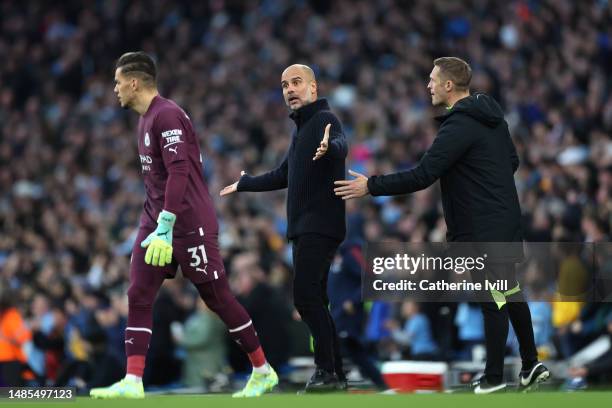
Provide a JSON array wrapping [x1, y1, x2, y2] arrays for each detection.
[[0, 0, 612, 388]]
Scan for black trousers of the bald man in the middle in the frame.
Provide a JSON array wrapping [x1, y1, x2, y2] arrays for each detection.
[[293, 234, 344, 379]]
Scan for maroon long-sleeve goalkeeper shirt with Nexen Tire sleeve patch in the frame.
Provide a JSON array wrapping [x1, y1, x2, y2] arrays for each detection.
[[138, 96, 219, 236]]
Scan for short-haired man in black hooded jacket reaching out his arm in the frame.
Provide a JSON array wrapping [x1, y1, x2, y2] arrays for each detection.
[[335, 57, 550, 394]]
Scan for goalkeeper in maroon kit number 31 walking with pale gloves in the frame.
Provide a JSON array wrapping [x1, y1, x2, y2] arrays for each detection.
[[90, 52, 278, 398]]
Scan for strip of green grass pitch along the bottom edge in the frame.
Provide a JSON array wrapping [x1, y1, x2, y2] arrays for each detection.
[[11, 391, 612, 408]]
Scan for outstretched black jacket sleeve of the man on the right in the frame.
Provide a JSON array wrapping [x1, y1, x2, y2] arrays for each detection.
[[368, 115, 473, 196]]
